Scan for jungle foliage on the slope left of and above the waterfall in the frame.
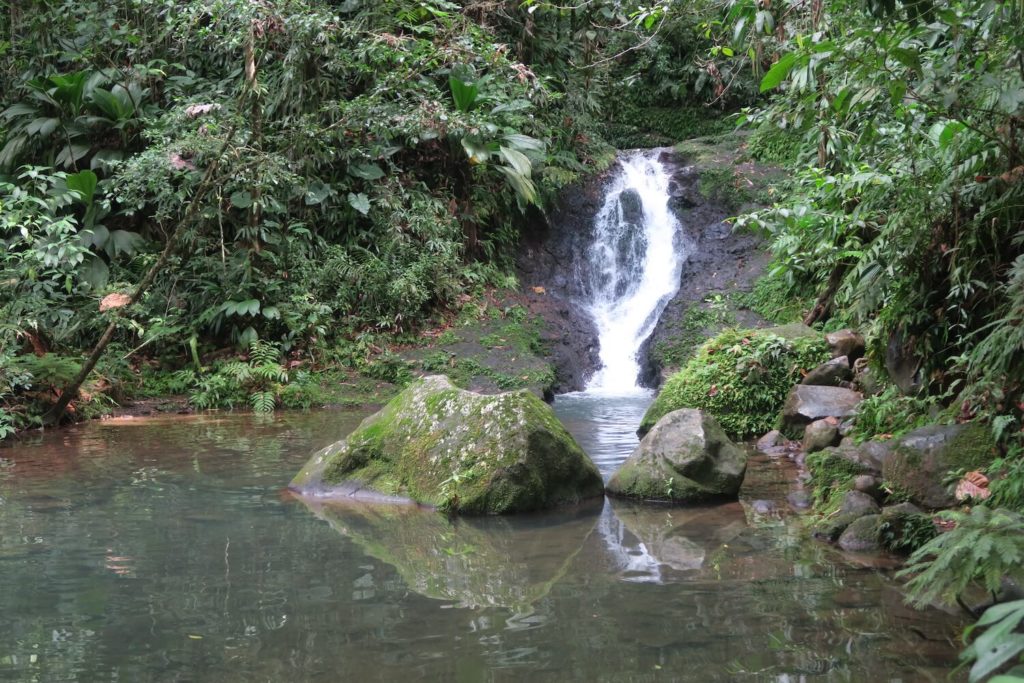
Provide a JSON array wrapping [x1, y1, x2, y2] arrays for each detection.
[[0, 0, 737, 434]]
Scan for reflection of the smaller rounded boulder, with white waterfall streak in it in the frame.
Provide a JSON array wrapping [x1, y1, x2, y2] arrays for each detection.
[[600, 501, 748, 583]]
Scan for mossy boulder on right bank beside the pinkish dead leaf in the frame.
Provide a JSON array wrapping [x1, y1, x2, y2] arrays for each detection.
[[882, 422, 995, 510]]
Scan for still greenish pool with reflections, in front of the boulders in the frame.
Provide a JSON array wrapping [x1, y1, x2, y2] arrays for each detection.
[[0, 405, 963, 682]]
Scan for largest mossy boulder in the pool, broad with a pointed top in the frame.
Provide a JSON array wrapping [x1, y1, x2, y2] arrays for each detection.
[[291, 377, 602, 515]]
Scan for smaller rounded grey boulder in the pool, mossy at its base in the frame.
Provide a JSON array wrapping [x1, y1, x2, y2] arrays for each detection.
[[607, 409, 746, 503]]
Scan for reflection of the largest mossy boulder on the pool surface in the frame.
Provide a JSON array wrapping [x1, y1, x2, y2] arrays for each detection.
[[303, 499, 600, 608]]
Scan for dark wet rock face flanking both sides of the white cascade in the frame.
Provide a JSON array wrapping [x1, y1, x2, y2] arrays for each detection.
[[516, 150, 769, 393]]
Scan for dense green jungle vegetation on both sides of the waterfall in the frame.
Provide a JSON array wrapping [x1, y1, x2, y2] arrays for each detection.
[[6, 0, 1024, 680]]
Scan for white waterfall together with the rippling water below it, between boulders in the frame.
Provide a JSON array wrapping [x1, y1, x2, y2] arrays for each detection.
[[554, 150, 686, 479]]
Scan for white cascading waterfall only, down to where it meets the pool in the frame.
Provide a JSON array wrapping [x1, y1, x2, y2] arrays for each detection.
[[583, 150, 684, 395]]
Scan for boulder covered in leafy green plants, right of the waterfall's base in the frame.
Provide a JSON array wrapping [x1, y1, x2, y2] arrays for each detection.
[[638, 326, 830, 438]]
